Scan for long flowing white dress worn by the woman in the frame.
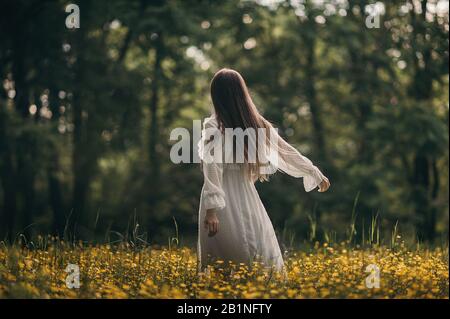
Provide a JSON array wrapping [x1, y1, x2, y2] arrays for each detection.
[[197, 114, 323, 271]]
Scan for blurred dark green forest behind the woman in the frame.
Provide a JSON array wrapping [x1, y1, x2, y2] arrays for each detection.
[[0, 0, 449, 247]]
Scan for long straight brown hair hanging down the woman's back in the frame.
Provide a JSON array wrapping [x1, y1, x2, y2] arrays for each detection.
[[211, 68, 271, 180]]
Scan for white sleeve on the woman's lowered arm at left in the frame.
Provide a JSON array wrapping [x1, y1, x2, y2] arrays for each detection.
[[198, 118, 225, 209]]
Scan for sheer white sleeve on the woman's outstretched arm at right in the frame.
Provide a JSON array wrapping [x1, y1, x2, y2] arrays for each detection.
[[270, 129, 324, 192]]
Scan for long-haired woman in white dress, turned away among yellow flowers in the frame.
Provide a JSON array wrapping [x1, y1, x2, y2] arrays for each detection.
[[198, 69, 330, 271]]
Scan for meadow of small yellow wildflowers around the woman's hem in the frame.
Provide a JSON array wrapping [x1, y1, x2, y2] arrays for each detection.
[[0, 240, 449, 298]]
